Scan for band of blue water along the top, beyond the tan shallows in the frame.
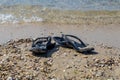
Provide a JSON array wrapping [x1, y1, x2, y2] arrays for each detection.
[[0, 0, 120, 10]]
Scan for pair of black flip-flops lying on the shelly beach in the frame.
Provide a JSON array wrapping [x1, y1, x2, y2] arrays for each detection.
[[30, 34, 94, 53]]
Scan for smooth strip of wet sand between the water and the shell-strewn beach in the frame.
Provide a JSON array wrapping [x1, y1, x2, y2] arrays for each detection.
[[0, 24, 120, 48]]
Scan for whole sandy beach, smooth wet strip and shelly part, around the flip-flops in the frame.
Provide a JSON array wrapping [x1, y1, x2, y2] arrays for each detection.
[[0, 24, 120, 80]]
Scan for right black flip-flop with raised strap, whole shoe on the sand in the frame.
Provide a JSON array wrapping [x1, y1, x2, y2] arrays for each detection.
[[53, 34, 94, 52]]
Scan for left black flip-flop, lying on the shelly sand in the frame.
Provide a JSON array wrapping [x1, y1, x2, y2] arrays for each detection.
[[30, 36, 55, 53]]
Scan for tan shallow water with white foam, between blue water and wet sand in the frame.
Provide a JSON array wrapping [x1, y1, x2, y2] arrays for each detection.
[[0, 6, 120, 25]]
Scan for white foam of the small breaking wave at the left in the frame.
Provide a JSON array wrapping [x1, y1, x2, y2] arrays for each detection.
[[0, 14, 43, 24]]
